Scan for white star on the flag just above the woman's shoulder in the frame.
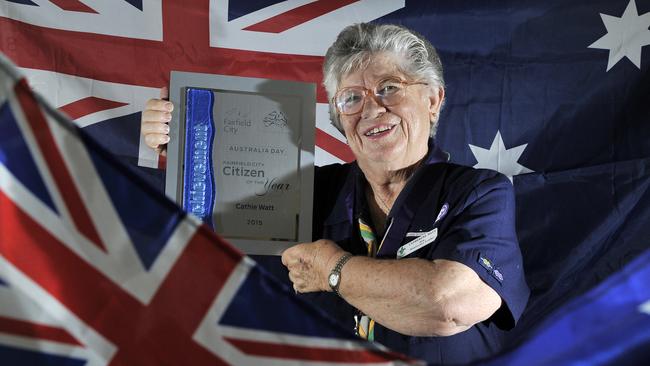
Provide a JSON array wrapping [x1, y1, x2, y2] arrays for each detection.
[[469, 131, 534, 182]]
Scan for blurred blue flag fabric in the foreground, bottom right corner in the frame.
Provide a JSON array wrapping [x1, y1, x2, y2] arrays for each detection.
[[485, 250, 650, 366]]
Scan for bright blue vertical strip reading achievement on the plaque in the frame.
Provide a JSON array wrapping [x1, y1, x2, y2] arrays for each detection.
[[183, 88, 216, 228]]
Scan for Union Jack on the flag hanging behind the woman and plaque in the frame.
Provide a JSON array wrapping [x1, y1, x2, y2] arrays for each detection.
[[0, 0, 404, 170]]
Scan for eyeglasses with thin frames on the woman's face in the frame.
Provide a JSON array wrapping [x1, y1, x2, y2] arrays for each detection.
[[332, 77, 429, 116]]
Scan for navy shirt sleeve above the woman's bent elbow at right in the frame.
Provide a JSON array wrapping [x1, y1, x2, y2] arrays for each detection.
[[436, 170, 530, 330]]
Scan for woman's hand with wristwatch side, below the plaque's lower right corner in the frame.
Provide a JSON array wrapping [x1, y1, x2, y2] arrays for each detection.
[[282, 239, 345, 293]]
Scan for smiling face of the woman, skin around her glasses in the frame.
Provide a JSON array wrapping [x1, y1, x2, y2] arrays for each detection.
[[339, 53, 444, 171]]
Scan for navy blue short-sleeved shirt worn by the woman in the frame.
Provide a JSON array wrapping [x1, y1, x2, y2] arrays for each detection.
[[313, 141, 529, 364]]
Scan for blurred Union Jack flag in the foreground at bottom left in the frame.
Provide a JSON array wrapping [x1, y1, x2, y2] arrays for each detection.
[[0, 55, 405, 365]]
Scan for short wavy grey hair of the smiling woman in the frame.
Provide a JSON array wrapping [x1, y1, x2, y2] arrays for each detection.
[[323, 23, 445, 136]]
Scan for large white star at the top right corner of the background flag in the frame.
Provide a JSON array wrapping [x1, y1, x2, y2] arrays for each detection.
[[589, 0, 650, 71]]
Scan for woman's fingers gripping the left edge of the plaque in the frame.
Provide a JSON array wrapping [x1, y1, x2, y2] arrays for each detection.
[[140, 87, 174, 155]]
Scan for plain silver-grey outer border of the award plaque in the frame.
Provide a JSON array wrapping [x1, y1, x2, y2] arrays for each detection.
[[165, 71, 316, 255]]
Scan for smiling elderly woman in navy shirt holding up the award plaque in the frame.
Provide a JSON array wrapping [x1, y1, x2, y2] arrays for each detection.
[[143, 24, 529, 363]]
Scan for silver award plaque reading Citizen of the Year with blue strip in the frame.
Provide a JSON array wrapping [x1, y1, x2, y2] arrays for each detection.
[[165, 72, 316, 254]]
